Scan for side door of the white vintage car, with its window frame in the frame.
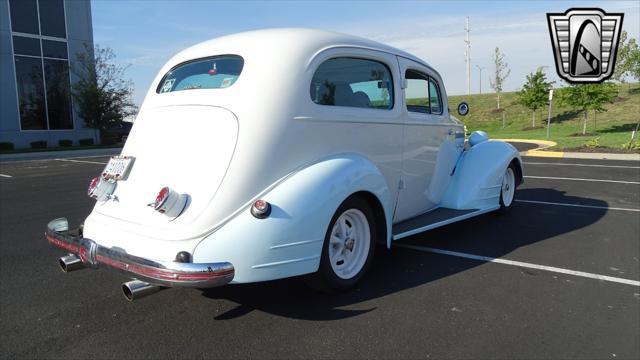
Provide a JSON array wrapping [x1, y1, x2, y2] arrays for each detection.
[[394, 57, 462, 222]]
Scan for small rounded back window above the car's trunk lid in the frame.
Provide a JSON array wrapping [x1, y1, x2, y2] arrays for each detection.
[[156, 55, 244, 94]]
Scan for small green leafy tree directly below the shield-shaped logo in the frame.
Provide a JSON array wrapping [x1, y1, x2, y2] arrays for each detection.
[[559, 83, 618, 135]]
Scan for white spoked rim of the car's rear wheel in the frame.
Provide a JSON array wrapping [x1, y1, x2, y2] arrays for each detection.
[[329, 209, 371, 280]]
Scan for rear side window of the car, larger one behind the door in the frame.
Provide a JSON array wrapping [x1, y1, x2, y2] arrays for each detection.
[[309, 57, 394, 110]]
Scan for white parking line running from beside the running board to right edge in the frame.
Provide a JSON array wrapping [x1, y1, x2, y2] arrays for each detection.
[[394, 244, 640, 286]]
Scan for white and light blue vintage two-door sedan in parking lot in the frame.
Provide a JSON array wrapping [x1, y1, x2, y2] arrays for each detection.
[[46, 29, 523, 300]]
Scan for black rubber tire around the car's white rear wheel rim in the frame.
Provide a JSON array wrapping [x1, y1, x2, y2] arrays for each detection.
[[305, 196, 380, 293]]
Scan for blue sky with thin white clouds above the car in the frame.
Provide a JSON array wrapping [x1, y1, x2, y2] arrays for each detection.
[[92, 0, 640, 104]]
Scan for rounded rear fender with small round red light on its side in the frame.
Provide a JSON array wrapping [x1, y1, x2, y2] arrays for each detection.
[[193, 154, 393, 283]]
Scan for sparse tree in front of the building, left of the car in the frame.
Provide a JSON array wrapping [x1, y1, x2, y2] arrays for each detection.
[[71, 45, 137, 142]]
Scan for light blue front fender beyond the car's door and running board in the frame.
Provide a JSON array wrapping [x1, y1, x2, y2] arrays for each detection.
[[442, 140, 522, 209]]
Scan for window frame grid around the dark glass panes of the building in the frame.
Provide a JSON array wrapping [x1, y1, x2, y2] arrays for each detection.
[[7, 0, 77, 132]]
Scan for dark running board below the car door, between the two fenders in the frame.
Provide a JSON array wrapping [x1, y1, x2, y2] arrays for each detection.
[[393, 205, 500, 241]]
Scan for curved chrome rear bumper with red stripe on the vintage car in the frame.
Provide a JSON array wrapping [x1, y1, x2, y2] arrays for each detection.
[[45, 218, 235, 288]]
